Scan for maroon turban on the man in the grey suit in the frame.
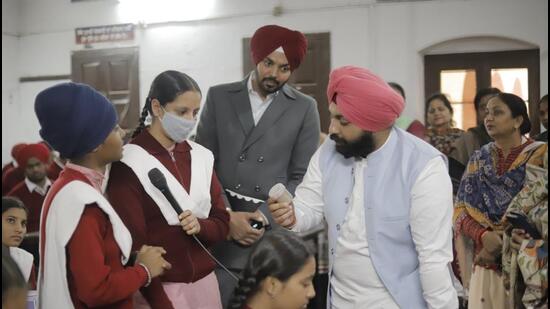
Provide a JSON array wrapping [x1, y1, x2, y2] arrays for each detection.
[[250, 25, 307, 71]]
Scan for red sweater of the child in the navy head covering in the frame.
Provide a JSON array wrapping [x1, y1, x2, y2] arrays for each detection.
[[40, 169, 147, 309]]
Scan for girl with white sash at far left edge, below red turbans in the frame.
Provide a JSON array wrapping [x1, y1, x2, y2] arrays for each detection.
[[2, 197, 36, 290]]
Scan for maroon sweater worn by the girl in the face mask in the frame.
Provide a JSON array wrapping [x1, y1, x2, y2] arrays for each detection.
[[107, 130, 229, 302]]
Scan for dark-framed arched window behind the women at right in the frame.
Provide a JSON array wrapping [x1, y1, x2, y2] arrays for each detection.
[[424, 49, 540, 135]]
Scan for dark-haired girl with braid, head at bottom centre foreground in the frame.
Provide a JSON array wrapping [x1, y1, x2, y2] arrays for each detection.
[[229, 231, 315, 309]]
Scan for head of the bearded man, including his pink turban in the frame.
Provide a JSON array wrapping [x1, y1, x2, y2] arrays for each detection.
[[327, 66, 405, 158]]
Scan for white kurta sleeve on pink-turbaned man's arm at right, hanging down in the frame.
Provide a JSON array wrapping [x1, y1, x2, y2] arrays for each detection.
[[410, 157, 458, 308]]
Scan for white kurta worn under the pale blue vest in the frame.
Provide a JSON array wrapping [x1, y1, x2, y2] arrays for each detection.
[[293, 131, 458, 308]]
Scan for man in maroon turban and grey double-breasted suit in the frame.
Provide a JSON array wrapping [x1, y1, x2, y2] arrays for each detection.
[[196, 25, 320, 306]]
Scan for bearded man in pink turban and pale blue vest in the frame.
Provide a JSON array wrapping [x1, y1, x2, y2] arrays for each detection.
[[269, 66, 458, 308]]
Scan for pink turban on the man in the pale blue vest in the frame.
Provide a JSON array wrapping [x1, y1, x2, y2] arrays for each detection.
[[327, 66, 405, 132]]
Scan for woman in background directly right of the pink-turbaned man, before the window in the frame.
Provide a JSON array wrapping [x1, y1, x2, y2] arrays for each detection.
[[424, 93, 464, 156]]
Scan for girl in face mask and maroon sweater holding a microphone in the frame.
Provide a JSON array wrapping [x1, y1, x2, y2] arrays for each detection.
[[107, 71, 229, 308]]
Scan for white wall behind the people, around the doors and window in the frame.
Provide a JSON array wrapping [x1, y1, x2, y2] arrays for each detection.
[[2, 0, 548, 162]]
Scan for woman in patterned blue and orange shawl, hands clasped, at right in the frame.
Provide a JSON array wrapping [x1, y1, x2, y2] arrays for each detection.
[[454, 93, 547, 309]]
